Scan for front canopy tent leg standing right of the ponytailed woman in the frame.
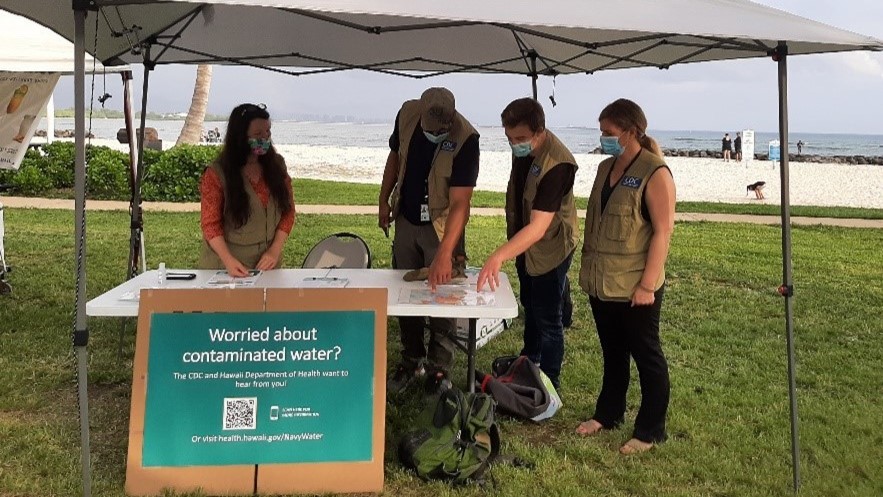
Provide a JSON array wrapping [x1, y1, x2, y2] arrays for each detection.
[[773, 41, 800, 493]]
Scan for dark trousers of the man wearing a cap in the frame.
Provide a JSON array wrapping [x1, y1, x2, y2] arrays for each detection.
[[392, 215, 465, 371]]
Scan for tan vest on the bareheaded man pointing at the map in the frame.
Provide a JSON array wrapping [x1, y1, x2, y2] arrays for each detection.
[[506, 130, 579, 276]]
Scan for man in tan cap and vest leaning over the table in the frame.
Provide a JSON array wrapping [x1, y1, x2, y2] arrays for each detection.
[[378, 88, 479, 393]]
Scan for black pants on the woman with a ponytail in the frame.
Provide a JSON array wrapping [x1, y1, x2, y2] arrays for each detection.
[[589, 286, 670, 443]]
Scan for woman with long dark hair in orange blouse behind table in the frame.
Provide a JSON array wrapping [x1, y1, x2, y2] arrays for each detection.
[[199, 104, 295, 277]]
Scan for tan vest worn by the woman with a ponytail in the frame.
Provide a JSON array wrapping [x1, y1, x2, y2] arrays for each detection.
[[579, 149, 665, 301]]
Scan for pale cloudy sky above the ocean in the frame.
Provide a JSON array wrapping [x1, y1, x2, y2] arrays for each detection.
[[55, 0, 883, 135]]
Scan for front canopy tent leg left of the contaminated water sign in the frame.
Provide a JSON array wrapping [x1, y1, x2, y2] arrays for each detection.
[[73, 0, 92, 497]]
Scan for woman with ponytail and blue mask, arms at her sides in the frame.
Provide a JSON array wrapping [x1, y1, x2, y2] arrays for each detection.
[[576, 99, 675, 455]]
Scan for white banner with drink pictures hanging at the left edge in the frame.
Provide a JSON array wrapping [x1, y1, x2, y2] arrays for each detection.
[[0, 71, 59, 169]]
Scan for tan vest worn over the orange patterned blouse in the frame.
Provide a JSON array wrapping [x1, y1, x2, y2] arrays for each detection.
[[199, 163, 282, 269]]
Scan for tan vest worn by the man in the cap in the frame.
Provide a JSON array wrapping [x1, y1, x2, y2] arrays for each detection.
[[392, 100, 478, 240]]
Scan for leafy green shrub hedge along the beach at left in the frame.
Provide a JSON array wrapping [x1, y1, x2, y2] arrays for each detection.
[[0, 142, 219, 202]]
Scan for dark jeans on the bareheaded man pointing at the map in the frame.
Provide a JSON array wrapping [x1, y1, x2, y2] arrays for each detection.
[[515, 252, 573, 389]]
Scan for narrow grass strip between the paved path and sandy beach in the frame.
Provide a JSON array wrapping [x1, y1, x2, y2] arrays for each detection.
[[294, 179, 883, 219]]
